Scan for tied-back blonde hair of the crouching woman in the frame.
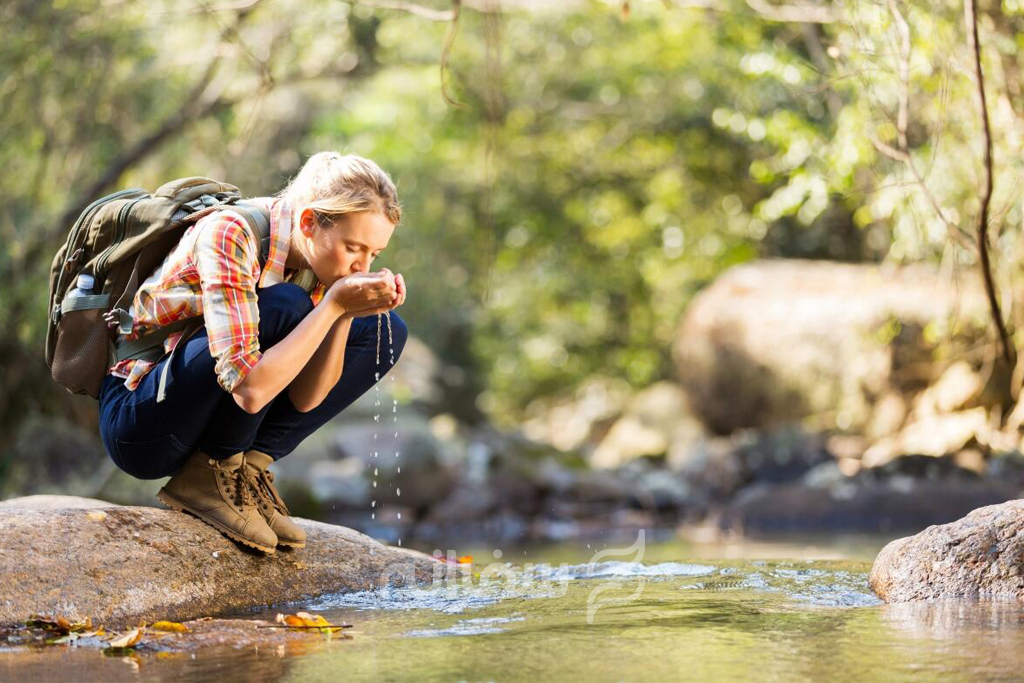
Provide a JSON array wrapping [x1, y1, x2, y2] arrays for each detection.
[[278, 152, 401, 225]]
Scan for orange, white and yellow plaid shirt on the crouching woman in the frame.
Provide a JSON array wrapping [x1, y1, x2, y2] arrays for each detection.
[[110, 198, 325, 392]]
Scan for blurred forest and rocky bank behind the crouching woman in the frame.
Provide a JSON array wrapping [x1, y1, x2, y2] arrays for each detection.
[[0, 0, 1024, 539]]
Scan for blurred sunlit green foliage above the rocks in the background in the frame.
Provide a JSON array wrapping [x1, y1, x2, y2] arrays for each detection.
[[0, 0, 1024, 438]]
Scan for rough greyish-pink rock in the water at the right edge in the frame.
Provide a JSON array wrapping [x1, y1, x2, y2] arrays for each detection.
[[868, 500, 1024, 602]]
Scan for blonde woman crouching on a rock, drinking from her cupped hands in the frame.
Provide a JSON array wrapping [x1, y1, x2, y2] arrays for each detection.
[[99, 153, 407, 553]]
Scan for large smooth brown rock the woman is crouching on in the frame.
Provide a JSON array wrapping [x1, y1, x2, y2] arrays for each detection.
[[0, 493, 435, 628]]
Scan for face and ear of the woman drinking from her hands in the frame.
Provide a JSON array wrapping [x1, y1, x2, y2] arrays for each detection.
[[299, 209, 394, 286]]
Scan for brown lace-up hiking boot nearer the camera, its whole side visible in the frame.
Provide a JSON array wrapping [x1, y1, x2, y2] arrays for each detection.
[[157, 451, 278, 554]]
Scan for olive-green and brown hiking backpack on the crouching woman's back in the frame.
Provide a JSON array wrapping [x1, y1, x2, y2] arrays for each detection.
[[46, 177, 270, 398]]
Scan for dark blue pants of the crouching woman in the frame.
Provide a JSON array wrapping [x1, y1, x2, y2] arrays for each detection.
[[99, 283, 408, 479]]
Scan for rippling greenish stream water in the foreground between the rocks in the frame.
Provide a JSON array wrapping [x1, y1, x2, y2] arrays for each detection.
[[0, 544, 1024, 683]]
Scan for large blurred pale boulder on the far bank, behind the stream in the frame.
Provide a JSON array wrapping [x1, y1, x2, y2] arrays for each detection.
[[674, 260, 988, 434]]
